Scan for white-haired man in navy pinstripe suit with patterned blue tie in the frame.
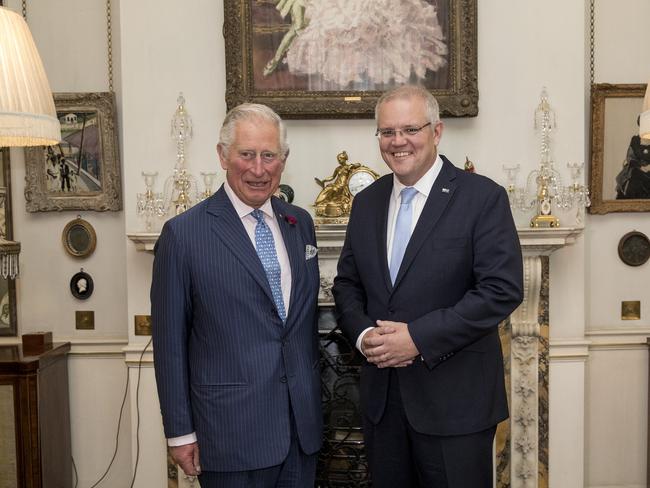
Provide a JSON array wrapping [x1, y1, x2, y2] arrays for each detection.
[[151, 104, 322, 488]]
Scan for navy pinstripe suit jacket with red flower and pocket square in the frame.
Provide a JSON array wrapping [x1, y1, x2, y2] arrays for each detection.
[[151, 187, 322, 471]]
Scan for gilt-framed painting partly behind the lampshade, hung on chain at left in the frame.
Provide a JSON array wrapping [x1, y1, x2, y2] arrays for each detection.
[[25, 92, 122, 212]]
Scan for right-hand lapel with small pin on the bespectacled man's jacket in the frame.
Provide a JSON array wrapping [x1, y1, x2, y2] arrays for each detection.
[[389, 156, 456, 289]]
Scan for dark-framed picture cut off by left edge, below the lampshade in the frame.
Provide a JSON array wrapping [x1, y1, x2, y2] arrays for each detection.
[[0, 148, 17, 336]]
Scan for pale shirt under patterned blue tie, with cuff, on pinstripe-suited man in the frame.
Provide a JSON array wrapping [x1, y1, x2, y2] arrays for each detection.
[[167, 181, 291, 447]]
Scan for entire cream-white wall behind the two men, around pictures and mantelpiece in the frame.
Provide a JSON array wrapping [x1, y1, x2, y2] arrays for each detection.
[[2, 0, 650, 487]]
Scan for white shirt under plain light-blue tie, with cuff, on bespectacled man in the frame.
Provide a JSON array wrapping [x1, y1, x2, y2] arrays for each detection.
[[356, 154, 442, 354]]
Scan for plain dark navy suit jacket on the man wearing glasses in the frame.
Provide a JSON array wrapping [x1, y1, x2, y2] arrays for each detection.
[[333, 157, 523, 435]]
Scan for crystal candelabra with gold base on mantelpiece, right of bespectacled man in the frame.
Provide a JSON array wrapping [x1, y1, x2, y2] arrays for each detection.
[[503, 88, 591, 227]]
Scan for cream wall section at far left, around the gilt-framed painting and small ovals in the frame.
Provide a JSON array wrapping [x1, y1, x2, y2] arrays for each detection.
[[5, 0, 126, 338]]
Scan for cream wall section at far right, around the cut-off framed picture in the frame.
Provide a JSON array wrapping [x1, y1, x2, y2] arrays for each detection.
[[584, 0, 650, 488]]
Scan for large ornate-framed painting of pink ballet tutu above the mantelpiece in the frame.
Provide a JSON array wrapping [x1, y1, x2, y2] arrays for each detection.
[[224, 0, 478, 118]]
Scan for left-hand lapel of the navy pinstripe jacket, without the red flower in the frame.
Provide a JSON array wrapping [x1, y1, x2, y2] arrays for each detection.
[[206, 186, 273, 303]]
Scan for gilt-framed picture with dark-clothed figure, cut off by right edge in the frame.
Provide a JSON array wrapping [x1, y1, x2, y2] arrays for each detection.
[[589, 84, 650, 214]]
